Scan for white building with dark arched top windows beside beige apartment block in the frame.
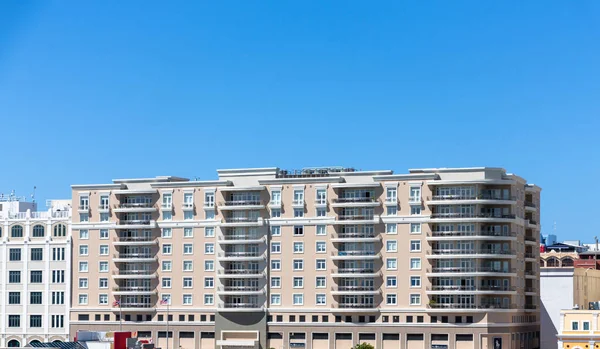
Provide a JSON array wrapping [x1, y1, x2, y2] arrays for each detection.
[[0, 196, 71, 347]]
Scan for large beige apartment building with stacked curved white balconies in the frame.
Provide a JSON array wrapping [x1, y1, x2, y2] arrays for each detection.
[[70, 168, 541, 349]]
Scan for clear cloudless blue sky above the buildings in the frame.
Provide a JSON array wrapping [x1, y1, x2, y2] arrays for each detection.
[[0, 0, 600, 240]]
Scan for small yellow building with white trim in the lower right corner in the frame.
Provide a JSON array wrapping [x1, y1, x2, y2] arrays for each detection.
[[557, 309, 600, 349]]
